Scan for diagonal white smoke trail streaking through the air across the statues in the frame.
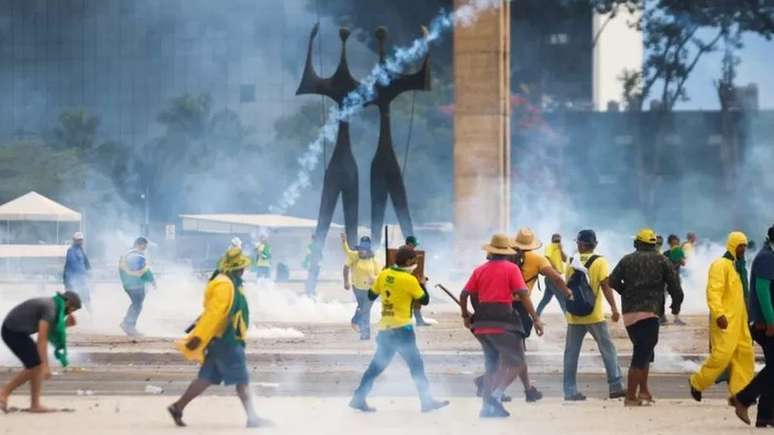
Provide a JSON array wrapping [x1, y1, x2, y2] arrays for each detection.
[[269, 0, 506, 214]]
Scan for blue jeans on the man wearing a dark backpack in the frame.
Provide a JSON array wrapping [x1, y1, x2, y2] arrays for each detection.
[[564, 321, 623, 397]]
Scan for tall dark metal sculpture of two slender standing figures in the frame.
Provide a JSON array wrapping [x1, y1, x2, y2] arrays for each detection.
[[296, 25, 430, 295]]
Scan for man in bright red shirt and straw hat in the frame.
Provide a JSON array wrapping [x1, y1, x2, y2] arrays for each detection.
[[460, 234, 543, 418]]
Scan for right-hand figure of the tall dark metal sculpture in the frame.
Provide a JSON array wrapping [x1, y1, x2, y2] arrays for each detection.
[[367, 27, 430, 245]]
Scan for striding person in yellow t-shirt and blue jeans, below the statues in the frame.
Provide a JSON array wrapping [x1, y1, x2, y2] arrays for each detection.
[[349, 246, 449, 412]]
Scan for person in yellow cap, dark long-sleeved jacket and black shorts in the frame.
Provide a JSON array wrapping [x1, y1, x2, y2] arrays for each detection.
[[609, 228, 683, 406]]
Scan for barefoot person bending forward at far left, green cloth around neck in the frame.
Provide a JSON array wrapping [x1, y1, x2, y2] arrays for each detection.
[[0, 291, 81, 413]]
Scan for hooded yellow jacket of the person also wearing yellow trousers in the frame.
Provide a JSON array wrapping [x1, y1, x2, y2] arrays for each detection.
[[707, 232, 747, 329]]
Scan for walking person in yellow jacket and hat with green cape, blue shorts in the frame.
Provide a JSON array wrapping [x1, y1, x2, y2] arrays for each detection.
[[167, 247, 272, 427]]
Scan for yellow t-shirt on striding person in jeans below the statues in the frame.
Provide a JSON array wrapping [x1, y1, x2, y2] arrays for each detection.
[[371, 267, 425, 330]]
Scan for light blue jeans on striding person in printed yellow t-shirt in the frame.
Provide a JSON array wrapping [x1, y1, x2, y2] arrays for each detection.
[[355, 326, 432, 403]]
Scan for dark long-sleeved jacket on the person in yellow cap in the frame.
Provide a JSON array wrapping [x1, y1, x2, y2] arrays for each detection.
[[609, 250, 684, 314]]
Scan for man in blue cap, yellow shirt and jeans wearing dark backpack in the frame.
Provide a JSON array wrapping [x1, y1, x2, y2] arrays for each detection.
[[564, 230, 628, 401]]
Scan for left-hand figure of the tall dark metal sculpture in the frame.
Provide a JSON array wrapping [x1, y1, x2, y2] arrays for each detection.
[[296, 24, 360, 295]]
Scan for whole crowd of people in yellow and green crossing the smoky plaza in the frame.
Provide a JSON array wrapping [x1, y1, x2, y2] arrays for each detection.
[[0, 226, 774, 427]]
